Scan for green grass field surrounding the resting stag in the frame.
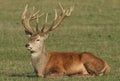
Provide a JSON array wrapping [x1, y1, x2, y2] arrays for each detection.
[[0, 0, 120, 81]]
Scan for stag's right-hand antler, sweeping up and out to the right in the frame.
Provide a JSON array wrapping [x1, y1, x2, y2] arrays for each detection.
[[41, 3, 74, 33]]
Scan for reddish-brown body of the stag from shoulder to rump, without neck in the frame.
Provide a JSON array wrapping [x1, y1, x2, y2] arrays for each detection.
[[40, 52, 109, 77]]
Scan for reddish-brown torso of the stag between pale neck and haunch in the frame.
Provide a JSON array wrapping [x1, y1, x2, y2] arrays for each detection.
[[45, 52, 88, 77]]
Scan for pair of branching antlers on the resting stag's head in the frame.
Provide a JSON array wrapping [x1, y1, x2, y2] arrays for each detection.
[[22, 3, 73, 35]]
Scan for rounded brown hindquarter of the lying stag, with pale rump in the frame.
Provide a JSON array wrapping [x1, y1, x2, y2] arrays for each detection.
[[80, 52, 110, 75]]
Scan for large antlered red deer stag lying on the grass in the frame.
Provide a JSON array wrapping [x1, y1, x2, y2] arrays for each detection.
[[21, 4, 110, 78]]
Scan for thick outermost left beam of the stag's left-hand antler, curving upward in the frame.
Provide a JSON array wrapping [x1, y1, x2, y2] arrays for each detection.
[[22, 5, 34, 34]]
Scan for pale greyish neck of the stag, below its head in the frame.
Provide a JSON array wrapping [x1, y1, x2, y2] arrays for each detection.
[[31, 45, 48, 74]]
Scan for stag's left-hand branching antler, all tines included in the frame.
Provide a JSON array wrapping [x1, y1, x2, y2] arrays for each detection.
[[22, 5, 43, 35]]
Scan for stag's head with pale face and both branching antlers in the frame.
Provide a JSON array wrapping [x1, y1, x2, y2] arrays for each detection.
[[22, 4, 73, 52]]
